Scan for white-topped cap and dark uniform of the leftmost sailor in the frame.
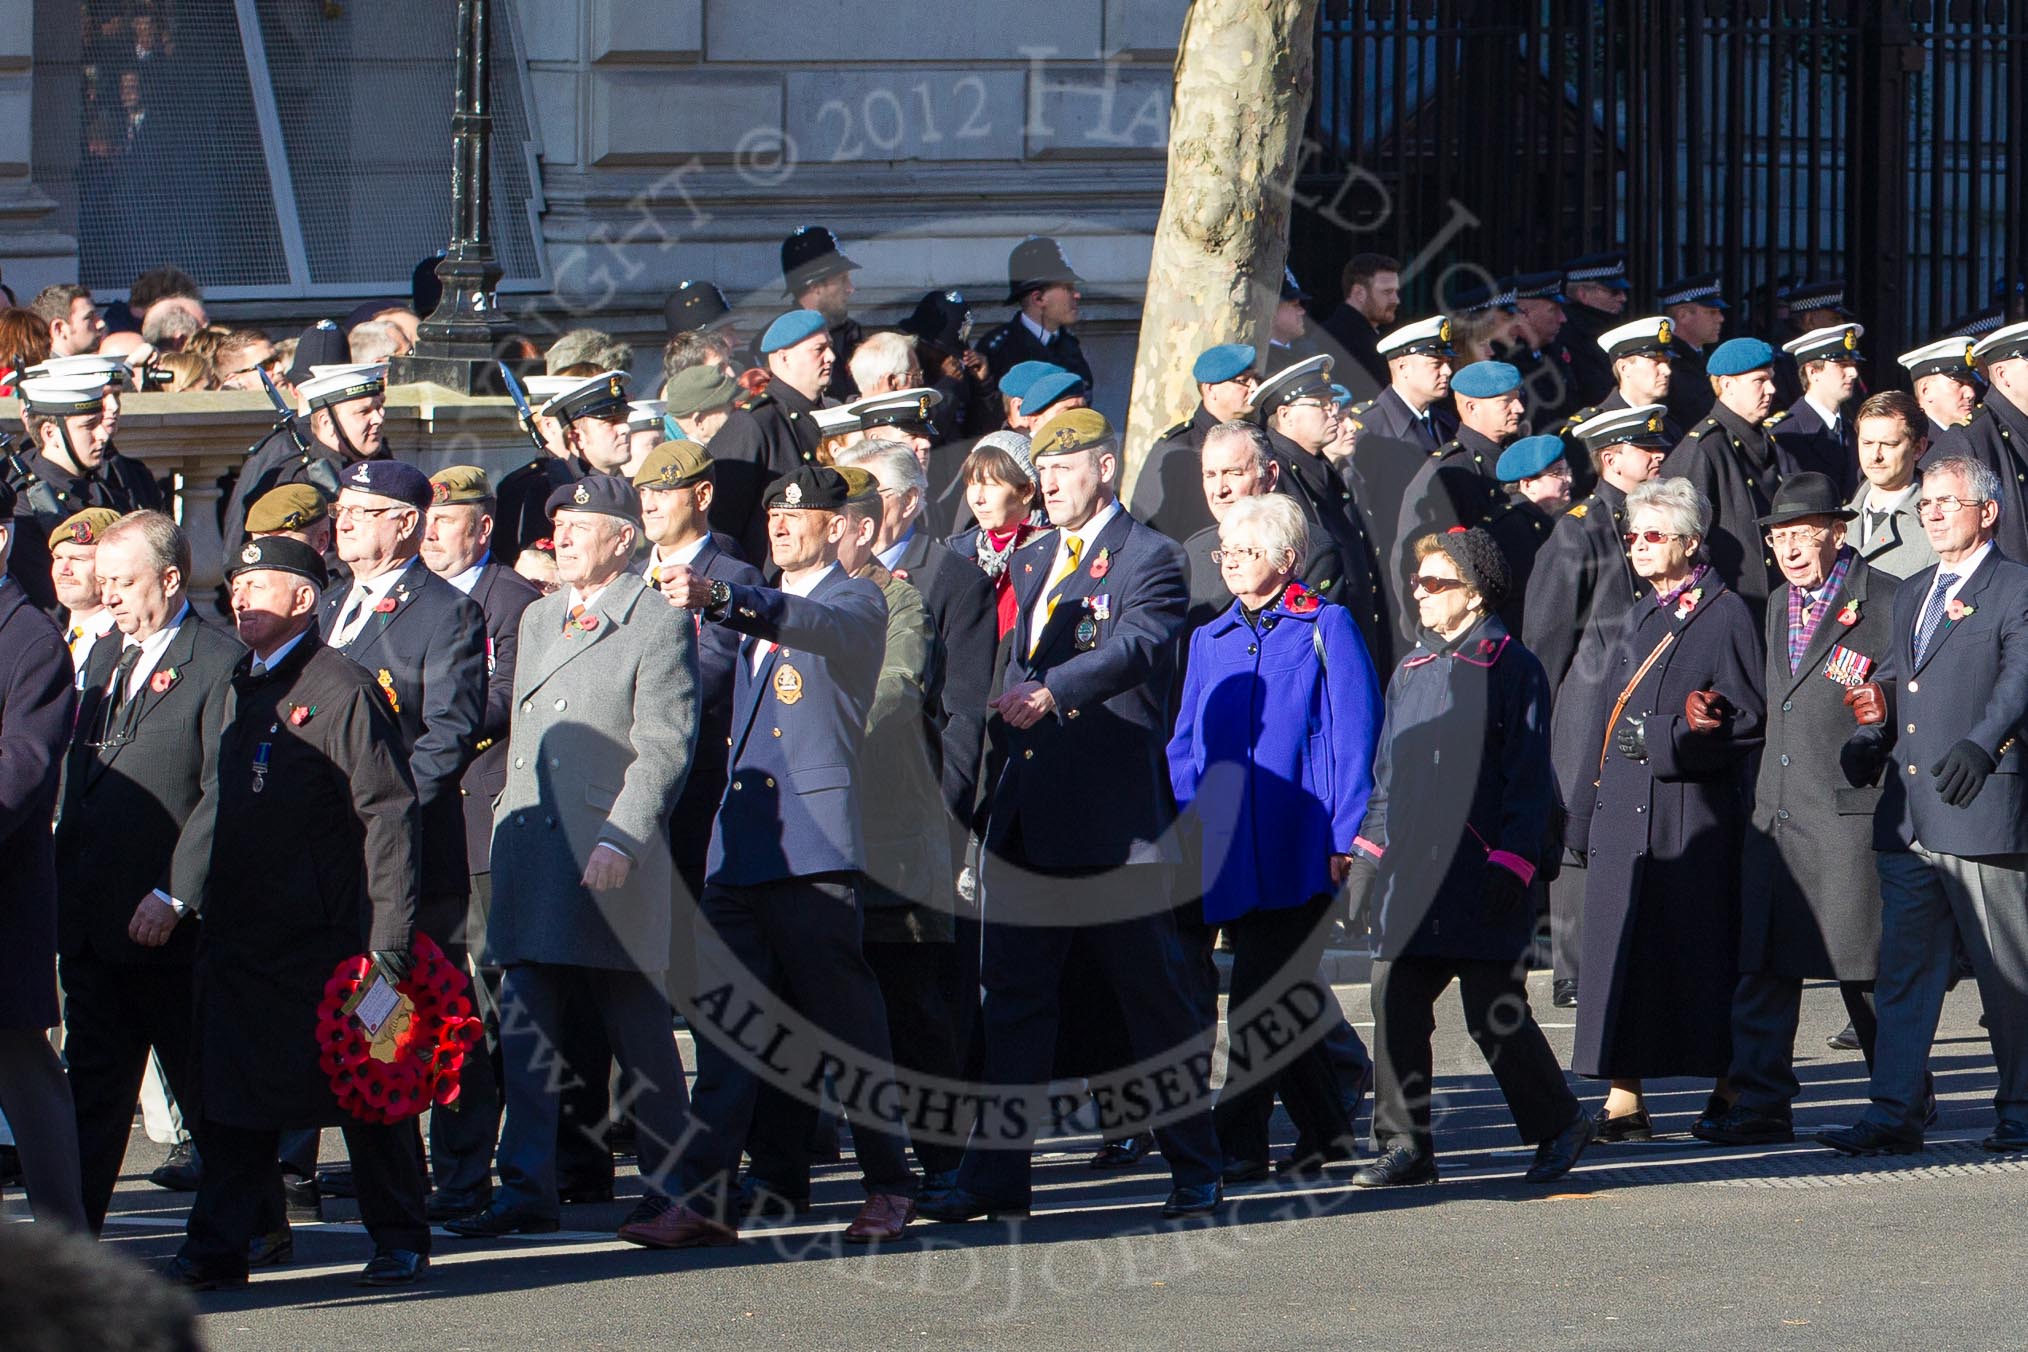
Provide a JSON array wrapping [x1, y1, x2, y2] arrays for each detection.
[[0, 364, 162, 614]]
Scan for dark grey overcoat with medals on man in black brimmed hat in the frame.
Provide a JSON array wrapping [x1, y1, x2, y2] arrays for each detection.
[[1740, 557, 1900, 981]]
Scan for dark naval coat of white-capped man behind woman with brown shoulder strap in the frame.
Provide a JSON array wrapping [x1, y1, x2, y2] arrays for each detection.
[[1521, 480, 1647, 831]]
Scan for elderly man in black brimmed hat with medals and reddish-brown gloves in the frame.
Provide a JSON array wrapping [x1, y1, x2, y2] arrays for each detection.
[[1693, 472, 1900, 1145]]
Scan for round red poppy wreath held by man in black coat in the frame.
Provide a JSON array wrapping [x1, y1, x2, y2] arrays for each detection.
[[316, 934, 485, 1123]]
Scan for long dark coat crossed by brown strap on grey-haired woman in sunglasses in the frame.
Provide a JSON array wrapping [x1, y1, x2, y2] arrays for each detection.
[[1572, 570, 1762, 1078]]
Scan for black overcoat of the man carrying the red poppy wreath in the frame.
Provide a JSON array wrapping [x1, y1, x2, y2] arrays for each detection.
[[184, 630, 420, 1129]]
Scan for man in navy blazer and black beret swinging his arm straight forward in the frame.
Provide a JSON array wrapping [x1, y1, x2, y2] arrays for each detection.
[[640, 464, 917, 1249]]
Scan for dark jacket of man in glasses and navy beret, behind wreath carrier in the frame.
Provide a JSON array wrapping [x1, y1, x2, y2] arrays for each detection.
[[318, 557, 487, 924]]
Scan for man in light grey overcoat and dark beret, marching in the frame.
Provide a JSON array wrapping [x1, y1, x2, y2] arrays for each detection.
[[448, 474, 698, 1238]]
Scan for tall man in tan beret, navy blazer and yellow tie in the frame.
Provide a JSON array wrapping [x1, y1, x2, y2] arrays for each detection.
[[923, 409, 1221, 1220]]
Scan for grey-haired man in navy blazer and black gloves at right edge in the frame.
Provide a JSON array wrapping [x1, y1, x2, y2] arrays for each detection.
[[1841, 454, 2028, 1155]]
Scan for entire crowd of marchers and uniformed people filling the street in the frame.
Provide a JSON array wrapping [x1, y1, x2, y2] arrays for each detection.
[[0, 227, 2028, 1287]]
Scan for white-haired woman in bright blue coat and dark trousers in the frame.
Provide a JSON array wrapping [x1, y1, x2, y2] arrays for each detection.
[[1168, 495, 1381, 1182]]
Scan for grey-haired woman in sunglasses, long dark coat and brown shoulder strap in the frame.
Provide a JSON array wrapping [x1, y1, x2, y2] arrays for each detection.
[[1570, 478, 1764, 1141]]
